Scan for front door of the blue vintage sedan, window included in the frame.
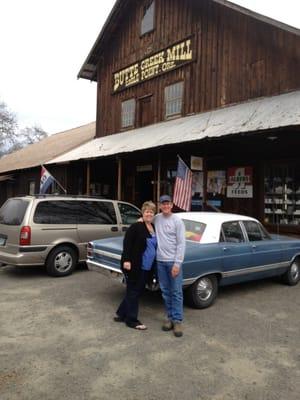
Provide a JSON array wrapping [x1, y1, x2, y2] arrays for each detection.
[[242, 221, 283, 276]]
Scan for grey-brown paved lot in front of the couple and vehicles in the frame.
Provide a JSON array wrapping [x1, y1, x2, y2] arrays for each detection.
[[0, 267, 300, 400]]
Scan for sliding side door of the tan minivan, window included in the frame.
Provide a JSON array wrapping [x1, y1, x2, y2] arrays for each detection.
[[77, 200, 121, 257]]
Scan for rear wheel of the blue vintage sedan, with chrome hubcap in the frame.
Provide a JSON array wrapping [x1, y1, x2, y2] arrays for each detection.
[[187, 275, 218, 309]]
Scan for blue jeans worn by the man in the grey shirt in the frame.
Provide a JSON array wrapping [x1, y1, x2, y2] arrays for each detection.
[[157, 261, 183, 322]]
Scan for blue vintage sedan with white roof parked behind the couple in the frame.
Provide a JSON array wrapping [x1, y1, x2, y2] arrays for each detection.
[[87, 212, 300, 308]]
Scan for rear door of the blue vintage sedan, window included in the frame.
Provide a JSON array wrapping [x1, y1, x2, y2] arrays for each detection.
[[220, 221, 252, 283]]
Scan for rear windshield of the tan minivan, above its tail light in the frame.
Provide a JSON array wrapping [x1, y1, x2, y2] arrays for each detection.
[[0, 199, 29, 225]]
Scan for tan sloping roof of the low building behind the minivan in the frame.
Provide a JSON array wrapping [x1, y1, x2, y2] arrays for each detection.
[[0, 122, 96, 173]]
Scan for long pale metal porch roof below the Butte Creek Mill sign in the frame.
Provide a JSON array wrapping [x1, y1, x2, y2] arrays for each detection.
[[48, 90, 300, 164]]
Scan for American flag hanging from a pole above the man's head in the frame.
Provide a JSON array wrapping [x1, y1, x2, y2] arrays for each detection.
[[173, 157, 193, 211]]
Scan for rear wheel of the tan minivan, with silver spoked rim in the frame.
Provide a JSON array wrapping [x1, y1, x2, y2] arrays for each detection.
[[46, 246, 78, 277]]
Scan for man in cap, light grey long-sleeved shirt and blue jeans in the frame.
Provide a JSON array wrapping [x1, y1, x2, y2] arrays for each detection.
[[154, 195, 185, 337]]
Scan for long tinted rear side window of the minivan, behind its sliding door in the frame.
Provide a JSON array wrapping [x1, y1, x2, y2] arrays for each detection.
[[33, 200, 79, 224]]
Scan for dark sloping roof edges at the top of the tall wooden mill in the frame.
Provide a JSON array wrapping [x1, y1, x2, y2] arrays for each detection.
[[78, 0, 300, 81]]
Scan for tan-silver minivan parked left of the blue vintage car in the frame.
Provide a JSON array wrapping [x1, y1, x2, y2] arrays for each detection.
[[0, 195, 141, 276]]
